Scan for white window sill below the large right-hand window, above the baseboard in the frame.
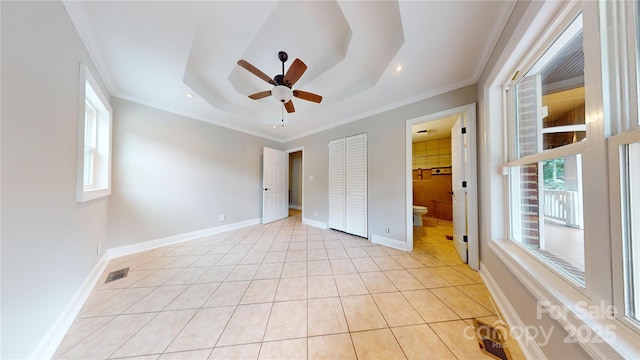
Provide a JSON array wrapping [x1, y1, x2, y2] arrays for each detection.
[[489, 240, 640, 359]]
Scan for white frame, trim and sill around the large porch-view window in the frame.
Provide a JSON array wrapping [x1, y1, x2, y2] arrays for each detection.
[[481, 1, 640, 359]]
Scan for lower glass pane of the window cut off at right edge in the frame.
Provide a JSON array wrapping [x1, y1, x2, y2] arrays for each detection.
[[625, 143, 640, 321]]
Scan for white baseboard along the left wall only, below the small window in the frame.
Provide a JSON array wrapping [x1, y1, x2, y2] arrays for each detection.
[[29, 253, 109, 359]]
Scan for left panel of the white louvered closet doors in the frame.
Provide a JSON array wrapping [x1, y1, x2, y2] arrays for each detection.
[[329, 139, 346, 231]]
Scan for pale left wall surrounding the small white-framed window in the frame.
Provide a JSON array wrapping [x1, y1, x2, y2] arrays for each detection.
[[0, 1, 109, 359]]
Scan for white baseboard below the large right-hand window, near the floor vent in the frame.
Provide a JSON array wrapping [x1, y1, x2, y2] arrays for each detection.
[[480, 262, 547, 359]]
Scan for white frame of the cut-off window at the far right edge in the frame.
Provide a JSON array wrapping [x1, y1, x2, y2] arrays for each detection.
[[600, 1, 640, 334]]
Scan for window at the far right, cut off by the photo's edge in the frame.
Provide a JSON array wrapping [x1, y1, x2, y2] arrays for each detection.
[[602, 1, 640, 333]]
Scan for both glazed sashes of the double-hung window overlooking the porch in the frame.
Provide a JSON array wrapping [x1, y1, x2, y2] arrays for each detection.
[[508, 15, 587, 286]]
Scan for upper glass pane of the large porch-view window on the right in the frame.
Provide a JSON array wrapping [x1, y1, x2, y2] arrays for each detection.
[[515, 16, 586, 158]]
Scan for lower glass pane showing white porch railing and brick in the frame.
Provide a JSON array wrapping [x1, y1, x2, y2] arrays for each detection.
[[510, 155, 585, 285]]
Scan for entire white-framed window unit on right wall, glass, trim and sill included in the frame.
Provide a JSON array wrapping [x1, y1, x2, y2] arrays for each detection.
[[481, 1, 640, 359]]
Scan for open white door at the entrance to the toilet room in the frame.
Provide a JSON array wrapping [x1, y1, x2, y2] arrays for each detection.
[[451, 117, 468, 263]]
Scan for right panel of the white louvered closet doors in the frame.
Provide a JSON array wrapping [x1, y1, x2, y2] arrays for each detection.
[[345, 134, 367, 237]]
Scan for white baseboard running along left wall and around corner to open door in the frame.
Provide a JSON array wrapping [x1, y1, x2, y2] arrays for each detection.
[[29, 218, 262, 359]]
